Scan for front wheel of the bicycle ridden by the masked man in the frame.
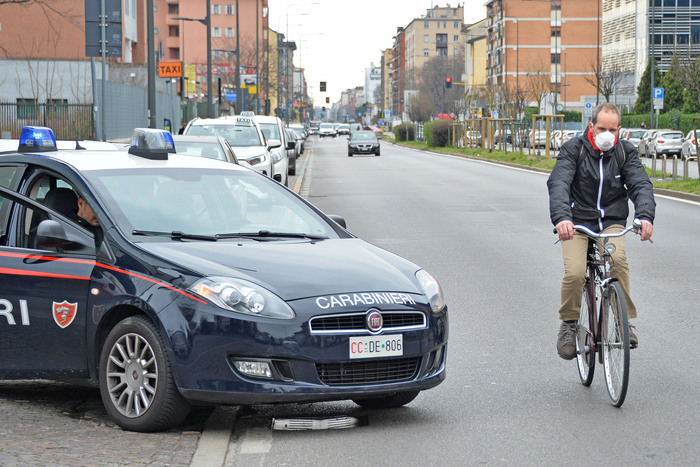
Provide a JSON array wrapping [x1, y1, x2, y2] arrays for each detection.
[[601, 282, 630, 407]]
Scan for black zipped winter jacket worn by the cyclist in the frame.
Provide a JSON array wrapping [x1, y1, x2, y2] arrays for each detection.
[[547, 129, 656, 232]]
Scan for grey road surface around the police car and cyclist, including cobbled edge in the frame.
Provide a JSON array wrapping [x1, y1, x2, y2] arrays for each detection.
[[0, 137, 700, 466]]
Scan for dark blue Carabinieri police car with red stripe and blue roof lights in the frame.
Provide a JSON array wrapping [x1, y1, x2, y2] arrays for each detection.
[[0, 127, 448, 431]]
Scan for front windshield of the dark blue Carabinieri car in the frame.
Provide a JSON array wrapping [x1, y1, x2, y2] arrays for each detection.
[[83, 167, 338, 241]]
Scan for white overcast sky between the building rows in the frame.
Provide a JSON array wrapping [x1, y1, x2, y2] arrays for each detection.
[[268, 0, 486, 106]]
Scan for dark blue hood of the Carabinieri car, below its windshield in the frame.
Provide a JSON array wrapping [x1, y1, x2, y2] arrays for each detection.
[[139, 238, 423, 301]]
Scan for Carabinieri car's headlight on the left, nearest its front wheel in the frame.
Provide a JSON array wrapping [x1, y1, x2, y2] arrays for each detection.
[[189, 277, 295, 319]]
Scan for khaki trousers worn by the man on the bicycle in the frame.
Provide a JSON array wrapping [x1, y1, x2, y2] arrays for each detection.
[[559, 225, 637, 321]]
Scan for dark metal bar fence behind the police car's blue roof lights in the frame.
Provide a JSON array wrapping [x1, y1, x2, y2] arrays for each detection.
[[0, 101, 95, 139]]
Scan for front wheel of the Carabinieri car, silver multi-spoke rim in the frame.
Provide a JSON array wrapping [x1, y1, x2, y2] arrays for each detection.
[[98, 316, 190, 432]]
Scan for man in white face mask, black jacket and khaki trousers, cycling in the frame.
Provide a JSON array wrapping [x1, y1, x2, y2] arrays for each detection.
[[547, 103, 656, 360]]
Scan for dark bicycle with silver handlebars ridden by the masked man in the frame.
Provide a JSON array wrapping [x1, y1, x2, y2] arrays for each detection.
[[574, 219, 642, 407]]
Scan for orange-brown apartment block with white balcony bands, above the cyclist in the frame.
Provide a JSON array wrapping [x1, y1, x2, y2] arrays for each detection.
[[486, 0, 600, 113]]
